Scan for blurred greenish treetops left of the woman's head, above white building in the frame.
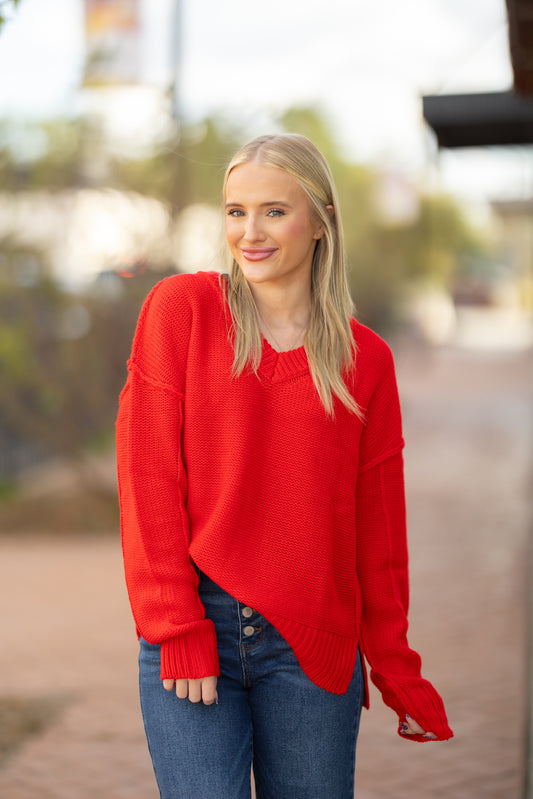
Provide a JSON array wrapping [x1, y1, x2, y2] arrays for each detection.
[[0, 117, 242, 208]]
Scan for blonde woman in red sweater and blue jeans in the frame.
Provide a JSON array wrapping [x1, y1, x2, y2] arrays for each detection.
[[117, 134, 453, 799]]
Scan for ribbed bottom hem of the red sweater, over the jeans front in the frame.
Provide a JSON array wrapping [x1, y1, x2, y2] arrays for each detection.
[[268, 613, 358, 694]]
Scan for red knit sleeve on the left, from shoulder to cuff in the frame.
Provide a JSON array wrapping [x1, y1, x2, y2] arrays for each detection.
[[116, 278, 219, 679]]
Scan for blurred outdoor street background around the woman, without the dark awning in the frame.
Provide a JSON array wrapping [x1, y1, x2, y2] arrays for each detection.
[[0, 0, 533, 799]]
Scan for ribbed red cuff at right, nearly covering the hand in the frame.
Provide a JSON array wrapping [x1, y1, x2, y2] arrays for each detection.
[[370, 671, 453, 743]]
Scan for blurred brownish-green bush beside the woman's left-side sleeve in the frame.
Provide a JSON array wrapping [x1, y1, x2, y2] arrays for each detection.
[[0, 241, 173, 477]]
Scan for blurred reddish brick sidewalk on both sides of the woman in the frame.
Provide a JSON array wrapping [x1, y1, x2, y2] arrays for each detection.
[[0, 351, 533, 799]]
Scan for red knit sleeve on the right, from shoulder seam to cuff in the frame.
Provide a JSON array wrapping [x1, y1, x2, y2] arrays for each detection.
[[357, 452, 453, 741]]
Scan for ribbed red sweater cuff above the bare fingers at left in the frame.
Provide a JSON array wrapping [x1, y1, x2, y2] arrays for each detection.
[[161, 619, 220, 680]]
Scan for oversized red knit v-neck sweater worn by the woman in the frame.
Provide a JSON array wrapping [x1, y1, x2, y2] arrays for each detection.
[[117, 272, 453, 740]]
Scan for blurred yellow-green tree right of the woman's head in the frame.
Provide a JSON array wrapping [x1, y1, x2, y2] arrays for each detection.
[[279, 108, 488, 332]]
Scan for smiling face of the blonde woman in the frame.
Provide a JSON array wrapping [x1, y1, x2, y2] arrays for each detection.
[[225, 161, 323, 286]]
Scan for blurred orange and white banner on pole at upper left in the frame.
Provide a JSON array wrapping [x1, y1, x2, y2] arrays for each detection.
[[83, 0, 140, 86]]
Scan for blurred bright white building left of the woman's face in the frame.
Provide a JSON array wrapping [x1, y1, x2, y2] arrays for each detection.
[[0, 188, 224, 289]]
